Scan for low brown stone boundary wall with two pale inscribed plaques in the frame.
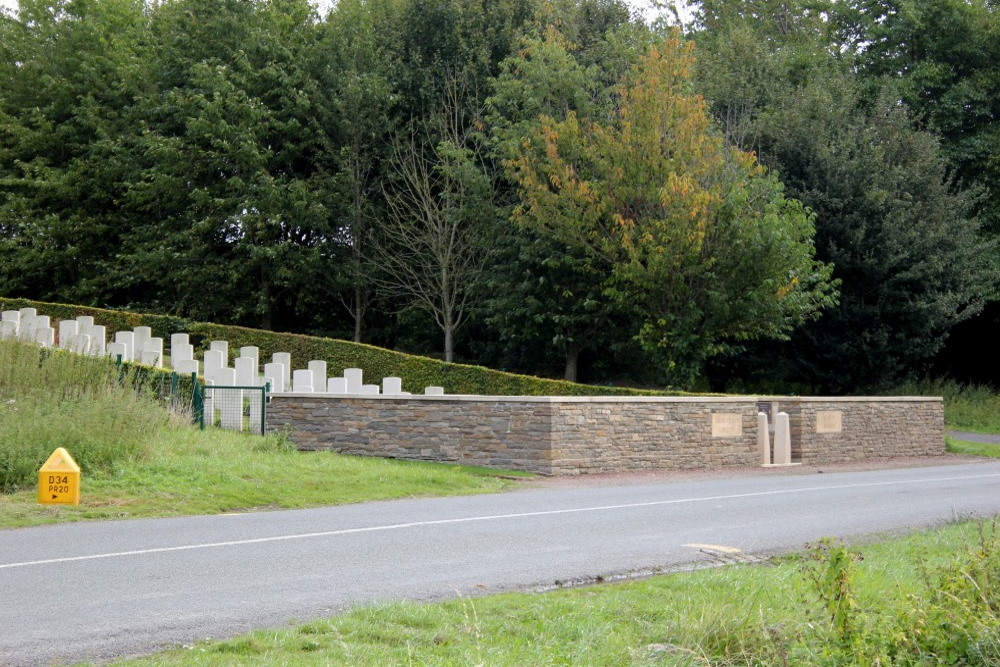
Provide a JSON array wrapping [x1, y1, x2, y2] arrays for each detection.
[[267, 394, 945, 475]]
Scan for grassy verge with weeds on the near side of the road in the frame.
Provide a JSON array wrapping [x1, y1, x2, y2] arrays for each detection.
[[95, 522, 1000, 666]]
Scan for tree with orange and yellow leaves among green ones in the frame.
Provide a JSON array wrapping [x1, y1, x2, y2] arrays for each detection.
[[505, 34, 836, 387]]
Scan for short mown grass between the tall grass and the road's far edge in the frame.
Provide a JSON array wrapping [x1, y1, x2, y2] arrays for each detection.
[[0, 428, 519, 528]]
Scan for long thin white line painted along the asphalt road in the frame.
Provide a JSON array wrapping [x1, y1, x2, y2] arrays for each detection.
[[0, 473, 1000, 570]]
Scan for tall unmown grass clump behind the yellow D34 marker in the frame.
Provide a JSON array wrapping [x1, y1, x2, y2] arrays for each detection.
[[0, 341, 171, 493]]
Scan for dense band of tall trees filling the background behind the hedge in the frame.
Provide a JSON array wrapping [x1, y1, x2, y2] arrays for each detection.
[[0, 0, 1000, 392]]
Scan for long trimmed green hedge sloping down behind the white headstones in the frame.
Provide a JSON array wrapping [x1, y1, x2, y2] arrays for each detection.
[[0, 297, 683, 396]]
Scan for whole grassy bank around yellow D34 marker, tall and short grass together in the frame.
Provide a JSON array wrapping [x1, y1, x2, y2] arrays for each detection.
[[0, 341, 532, 528]]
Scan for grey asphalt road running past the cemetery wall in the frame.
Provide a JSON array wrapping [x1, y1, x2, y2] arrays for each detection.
[[0, 461, 1000, 665]]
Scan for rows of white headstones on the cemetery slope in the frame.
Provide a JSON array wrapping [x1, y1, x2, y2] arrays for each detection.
[[0, 308, 444, 430]]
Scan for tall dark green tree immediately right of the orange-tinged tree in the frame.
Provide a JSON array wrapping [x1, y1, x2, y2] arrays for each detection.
[[698, 0, 997, 392]]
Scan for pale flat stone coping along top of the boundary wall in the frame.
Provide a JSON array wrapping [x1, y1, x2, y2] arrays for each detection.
[[271, 392, 944, 403]]
